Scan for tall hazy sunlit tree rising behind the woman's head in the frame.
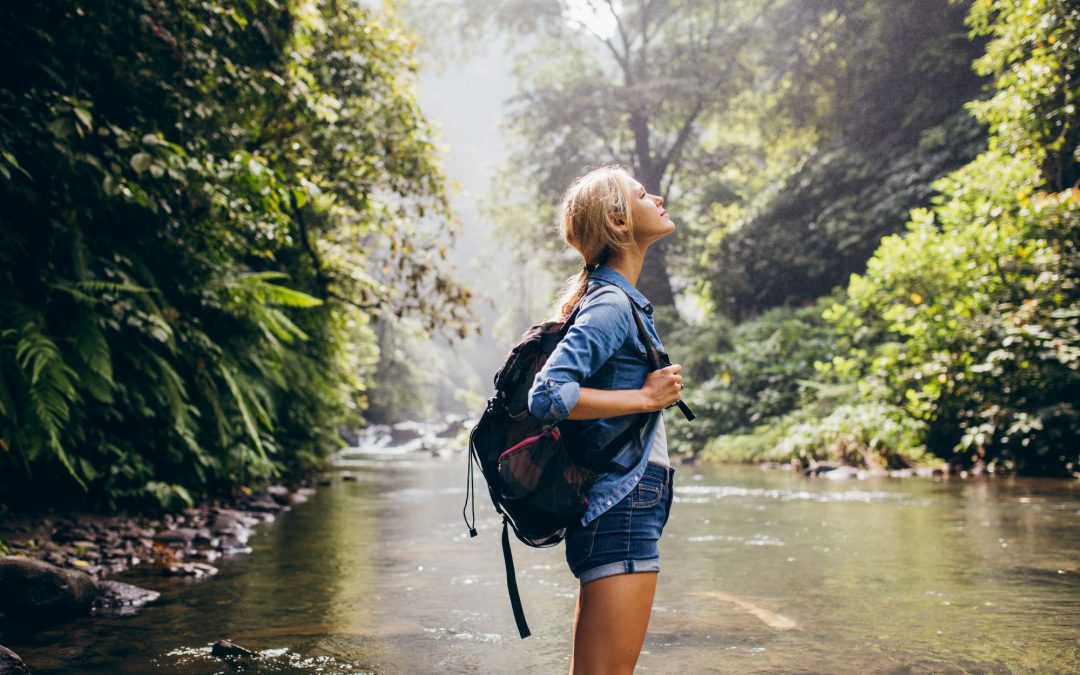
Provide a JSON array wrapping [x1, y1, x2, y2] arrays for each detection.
[[414, 0, 786, 306]]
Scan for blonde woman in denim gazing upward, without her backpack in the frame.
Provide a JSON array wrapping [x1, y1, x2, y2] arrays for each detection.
[[529, 166, 683, 674]]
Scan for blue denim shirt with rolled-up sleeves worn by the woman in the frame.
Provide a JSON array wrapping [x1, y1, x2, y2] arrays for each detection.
[[529, 266, 663, 525]]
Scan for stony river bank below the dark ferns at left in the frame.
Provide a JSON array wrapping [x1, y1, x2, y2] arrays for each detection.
[[0, 420, 462, 675]]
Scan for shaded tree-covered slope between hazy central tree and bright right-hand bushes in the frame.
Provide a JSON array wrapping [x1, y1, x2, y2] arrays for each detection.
[[686, 0, 985, 321]]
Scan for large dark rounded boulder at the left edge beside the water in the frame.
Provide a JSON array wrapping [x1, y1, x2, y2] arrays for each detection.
[[0, 556, 97, 617]]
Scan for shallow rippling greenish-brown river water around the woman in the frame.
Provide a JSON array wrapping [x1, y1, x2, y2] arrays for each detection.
[[0, 453, 1080, 674]]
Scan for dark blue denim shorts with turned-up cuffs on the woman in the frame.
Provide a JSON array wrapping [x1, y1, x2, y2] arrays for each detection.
[[566, 464, 675, 584]]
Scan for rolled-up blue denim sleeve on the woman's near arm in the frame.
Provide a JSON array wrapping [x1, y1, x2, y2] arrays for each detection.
[[529, 288, 631, 422]]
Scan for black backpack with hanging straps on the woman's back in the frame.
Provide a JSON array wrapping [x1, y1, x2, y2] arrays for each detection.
[[461, 286, 693, 638]]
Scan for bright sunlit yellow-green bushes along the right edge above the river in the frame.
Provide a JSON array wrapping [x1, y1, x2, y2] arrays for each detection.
[[822, 1, 1080, 473]]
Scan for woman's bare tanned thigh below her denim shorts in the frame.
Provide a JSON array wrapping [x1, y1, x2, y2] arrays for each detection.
[[570, 572, 657, 675]]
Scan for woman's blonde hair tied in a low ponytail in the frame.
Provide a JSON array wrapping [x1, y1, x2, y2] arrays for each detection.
[[551, 164, 634, 321]]
